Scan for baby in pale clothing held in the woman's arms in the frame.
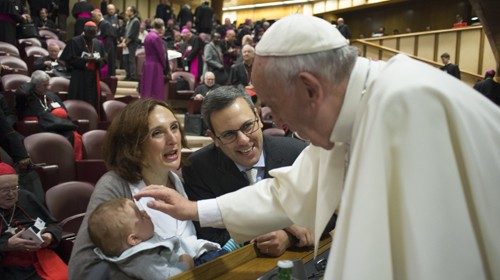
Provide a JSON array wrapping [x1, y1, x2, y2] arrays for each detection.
[[88, 198, 194, 279]]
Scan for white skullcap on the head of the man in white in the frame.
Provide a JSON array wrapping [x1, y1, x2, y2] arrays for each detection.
[[255, 14, 348, 56]]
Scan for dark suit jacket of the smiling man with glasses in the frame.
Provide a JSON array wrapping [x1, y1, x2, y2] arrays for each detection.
[[182, 136, 307, 246]]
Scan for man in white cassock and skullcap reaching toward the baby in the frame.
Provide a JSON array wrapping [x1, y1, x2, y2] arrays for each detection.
[[135, 15, 500, 280]]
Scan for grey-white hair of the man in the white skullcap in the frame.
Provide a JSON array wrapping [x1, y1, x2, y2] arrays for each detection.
[[264, 46, 358, 90]]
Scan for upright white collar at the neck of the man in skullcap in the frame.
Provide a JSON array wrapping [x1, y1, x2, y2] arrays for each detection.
[[330, 57, 370, 144]]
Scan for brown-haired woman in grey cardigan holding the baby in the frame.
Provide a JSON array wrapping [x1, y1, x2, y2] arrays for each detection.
[[69, 99, 220, 279]]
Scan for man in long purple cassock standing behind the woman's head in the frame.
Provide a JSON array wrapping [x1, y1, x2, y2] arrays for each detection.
[[140, 29, 167, 101]]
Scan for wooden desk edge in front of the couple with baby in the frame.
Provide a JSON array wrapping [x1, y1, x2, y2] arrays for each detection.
[[171, 237, 331, 280]]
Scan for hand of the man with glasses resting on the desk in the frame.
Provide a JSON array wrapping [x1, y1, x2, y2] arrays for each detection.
[[253, 230, 291, 257]]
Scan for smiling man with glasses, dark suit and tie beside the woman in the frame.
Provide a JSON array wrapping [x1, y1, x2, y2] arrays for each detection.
[[182, 86, 312, 256]]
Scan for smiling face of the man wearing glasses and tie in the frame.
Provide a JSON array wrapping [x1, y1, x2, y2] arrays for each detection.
[[209, 98, 263, 168]]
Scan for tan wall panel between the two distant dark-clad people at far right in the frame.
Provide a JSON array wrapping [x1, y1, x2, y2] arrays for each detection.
[[458, 30, 481, 73]]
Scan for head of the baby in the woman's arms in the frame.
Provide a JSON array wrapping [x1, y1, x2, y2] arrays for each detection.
[[88, 198, 154, 257]]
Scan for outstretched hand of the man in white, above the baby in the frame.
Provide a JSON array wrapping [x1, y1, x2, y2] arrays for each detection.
[[134, 185, 198, 221]]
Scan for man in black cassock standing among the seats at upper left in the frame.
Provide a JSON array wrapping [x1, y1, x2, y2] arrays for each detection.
[[59, 21, 106, 112]]
